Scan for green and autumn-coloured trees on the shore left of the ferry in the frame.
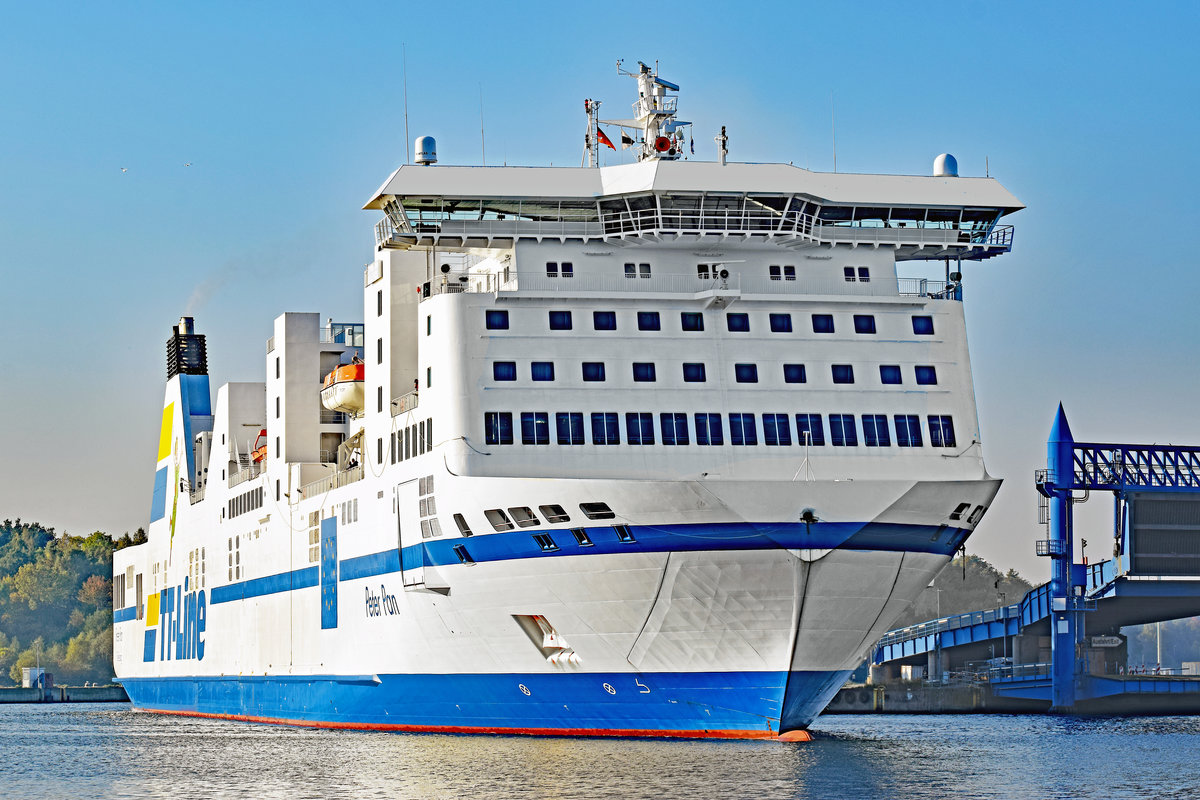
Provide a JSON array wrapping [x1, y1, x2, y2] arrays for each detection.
[[0, 519, 145, 686]]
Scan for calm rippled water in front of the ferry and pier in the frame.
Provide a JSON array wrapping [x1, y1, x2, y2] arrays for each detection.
[[0, 704, 1200, 800]]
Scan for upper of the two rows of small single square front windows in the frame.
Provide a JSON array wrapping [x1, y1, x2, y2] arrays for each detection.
[[482, 308, 934, 333]]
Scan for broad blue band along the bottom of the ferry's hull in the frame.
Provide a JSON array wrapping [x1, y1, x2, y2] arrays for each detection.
[[121, 670, 846, 735]]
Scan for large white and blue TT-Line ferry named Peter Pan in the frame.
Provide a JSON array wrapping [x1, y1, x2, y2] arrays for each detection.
[[113, 65, 1022, 739]]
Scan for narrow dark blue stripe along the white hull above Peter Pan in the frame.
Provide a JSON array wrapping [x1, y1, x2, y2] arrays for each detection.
[[199, 522, 970, 606]]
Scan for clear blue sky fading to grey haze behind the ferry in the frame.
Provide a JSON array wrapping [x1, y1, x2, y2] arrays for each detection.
[[0, 0, 1200, 579]]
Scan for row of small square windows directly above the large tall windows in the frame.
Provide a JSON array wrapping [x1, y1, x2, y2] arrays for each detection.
[[492, 361, 937, 386]]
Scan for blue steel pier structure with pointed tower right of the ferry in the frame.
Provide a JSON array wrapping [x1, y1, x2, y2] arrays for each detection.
[[872, 405, 1200, 714]]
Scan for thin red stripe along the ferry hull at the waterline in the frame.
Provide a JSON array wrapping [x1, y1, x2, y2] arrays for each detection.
[[136, 709, 812, 741]]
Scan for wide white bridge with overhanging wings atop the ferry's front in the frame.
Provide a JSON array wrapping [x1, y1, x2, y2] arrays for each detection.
[[365, 162, 1024, 260]]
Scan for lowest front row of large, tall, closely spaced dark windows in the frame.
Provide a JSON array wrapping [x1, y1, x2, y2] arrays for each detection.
[[484, 411, 956, 447]]
